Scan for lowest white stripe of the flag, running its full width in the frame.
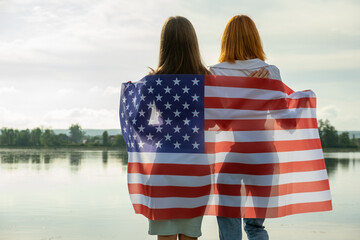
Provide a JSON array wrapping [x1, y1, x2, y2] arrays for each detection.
[[130, 190, 331, 209]]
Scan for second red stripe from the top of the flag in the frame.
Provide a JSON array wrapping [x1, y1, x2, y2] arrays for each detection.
[[204, 97, 316, 111]]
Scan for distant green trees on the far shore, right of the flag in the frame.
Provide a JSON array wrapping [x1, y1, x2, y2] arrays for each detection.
[[318, 119, 359, 148]]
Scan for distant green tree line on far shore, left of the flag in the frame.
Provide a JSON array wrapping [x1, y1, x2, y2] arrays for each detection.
[[0, 124, 126, 148]]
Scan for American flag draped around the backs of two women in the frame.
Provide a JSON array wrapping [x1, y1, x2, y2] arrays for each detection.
[[120, 75, 332, 220]]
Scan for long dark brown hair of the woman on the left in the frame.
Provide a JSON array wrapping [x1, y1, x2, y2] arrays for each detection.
[[151, 16, 210, 74]]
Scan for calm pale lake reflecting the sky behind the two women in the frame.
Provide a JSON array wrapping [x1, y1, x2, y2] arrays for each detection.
[[0, 149, 360, 240]]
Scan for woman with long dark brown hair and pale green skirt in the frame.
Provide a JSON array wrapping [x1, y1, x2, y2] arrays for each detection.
[[149, 16, 210, 240]]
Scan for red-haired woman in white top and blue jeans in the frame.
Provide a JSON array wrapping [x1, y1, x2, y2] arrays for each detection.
[[210, 15, 281, 240]]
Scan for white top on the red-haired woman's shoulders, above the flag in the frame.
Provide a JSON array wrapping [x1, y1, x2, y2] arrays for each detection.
[[210, 58, 281, 80]]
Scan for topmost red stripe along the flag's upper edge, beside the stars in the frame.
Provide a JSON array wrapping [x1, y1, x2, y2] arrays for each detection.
[[205, 75, 294, 94]]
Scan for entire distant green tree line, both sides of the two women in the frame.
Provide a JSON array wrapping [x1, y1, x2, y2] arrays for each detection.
[[0, 120, 359, 149]]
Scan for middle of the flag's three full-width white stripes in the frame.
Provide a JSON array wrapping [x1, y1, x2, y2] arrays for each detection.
[[128, 169, 327, 187]]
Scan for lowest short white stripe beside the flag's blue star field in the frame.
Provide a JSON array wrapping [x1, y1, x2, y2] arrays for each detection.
[[205, 128, 319, 142]]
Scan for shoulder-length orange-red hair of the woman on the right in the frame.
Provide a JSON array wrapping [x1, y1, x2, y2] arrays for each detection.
[[219, 15, 266, 63]]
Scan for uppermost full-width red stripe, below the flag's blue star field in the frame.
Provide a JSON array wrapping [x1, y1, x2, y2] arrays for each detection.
[[128, 159, 325, 176]]
